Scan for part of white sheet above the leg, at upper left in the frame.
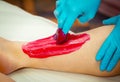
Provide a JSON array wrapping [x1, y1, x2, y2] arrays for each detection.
[[0, 1, 57, 41]]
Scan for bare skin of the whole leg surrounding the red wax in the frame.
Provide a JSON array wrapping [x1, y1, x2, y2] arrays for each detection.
[[0, 26, 120, 76]]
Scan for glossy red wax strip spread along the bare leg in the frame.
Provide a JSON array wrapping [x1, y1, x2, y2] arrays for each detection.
[[22, 33, 90, 58]]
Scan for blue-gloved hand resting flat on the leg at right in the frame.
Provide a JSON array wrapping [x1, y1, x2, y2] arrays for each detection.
[[96, 15, 120, 72]]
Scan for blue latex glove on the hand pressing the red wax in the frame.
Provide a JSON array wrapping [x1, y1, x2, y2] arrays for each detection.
[[54, 0, 101, 34]]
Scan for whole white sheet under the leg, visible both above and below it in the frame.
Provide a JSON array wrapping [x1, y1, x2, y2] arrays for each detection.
[[0, 0, 120, 82]]
